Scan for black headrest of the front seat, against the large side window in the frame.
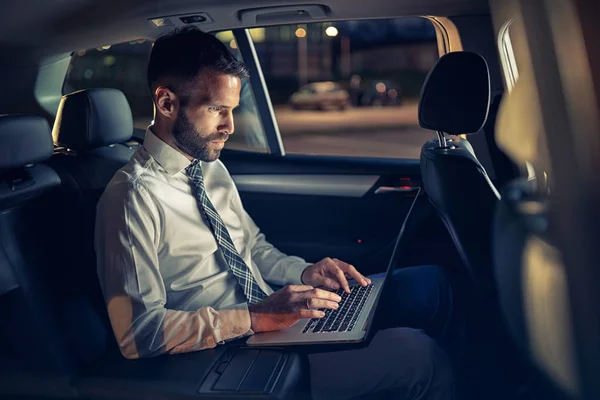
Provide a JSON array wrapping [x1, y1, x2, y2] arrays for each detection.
[[419, 51, 491, 135]]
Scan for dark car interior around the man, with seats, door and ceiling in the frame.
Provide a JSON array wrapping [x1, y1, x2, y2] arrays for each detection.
[[0, 0, 600, 400]]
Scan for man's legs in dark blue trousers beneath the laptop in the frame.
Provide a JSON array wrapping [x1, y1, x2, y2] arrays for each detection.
[[309, 328, 453, 400]]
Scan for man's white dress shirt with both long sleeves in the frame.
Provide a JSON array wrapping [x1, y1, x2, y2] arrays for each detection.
[[95, 128, 309, 358]]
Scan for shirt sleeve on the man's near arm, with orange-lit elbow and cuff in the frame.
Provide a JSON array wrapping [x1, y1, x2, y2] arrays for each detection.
[[95, 183, 253, 359]]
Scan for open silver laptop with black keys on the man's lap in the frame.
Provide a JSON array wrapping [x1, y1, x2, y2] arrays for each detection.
[[246, 188, 421, 347]]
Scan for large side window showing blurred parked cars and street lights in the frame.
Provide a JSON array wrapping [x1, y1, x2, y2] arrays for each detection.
[[254, 18, 439, 159]]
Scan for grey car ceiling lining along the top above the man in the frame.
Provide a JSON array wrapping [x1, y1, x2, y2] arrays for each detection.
[[0, 0, 489, 61]]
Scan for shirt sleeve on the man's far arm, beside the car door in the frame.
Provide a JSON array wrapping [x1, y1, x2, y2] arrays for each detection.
[[227, 177, 311, 286]]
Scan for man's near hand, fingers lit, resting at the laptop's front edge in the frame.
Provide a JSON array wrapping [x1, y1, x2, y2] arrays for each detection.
[[248, 285, 341, 333]]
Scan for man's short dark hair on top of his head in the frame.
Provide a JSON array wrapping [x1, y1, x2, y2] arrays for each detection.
[[148, 26, 248, 97]]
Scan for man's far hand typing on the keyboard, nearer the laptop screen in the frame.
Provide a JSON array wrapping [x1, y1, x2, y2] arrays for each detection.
[[302, 258, 371, 293]]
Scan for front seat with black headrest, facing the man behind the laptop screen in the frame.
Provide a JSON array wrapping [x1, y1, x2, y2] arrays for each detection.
[[419, 51, 536, 398]]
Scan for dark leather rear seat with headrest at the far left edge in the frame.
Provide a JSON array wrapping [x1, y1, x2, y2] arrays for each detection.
[[0, 107, 310, 400]]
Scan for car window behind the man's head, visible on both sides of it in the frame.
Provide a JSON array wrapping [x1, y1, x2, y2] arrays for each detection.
[[63, 31, 269, 153]]
